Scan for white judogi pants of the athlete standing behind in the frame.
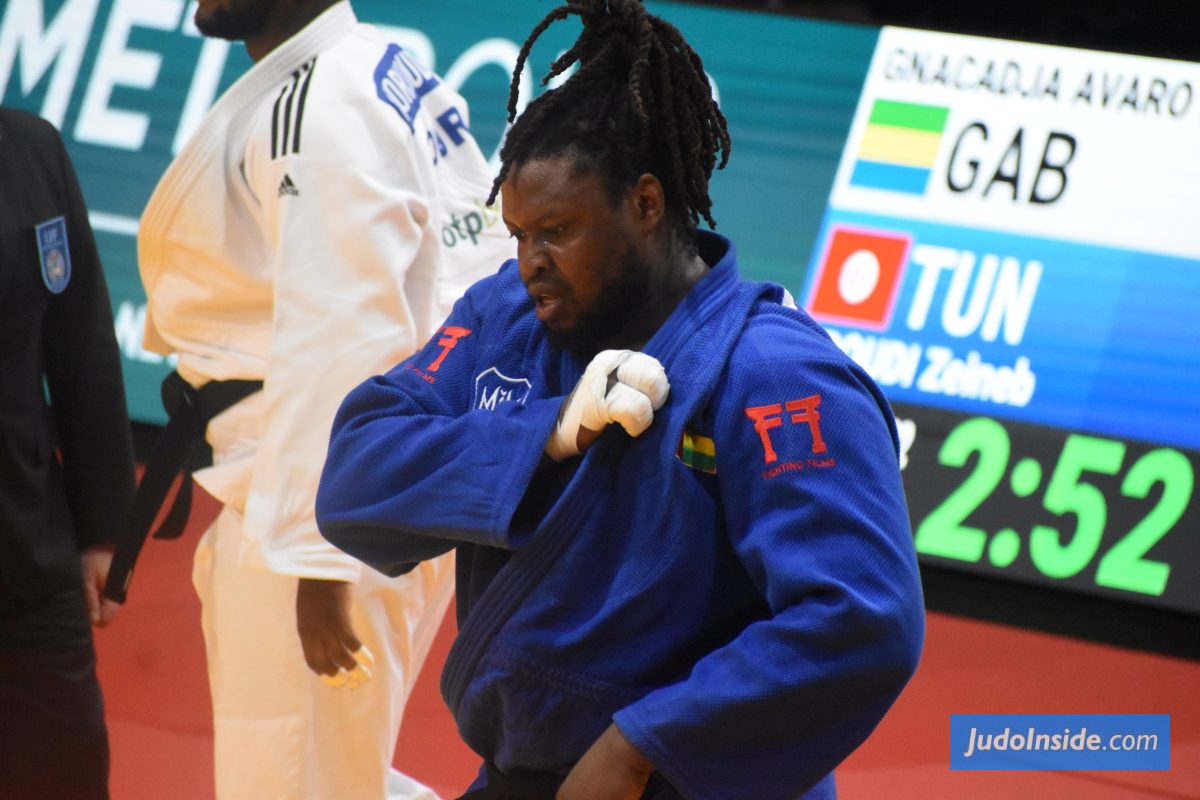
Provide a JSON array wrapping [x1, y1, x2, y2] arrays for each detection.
[[192, 506, 454, 800]]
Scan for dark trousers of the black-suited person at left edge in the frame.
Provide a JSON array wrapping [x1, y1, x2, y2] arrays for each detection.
[[0, 585, 108, 800]]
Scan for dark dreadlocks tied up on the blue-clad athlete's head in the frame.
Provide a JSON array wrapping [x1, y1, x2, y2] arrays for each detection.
[[487, 0, 730, 239]]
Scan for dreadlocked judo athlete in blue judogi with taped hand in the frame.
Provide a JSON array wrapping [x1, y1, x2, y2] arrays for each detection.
[[317, 0, 923, 800]]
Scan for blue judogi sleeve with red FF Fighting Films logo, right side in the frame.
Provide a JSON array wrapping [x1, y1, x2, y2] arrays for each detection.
[[614, 311, 924, 799]]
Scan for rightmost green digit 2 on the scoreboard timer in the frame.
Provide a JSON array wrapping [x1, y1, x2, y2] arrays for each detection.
[[1096, 450, 1195, 596]]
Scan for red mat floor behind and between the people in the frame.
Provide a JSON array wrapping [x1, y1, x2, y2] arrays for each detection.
[[96, 491, 1200, 800]]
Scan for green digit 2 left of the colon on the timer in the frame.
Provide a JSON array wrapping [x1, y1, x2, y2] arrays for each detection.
[[914, 416, 1012, 563]]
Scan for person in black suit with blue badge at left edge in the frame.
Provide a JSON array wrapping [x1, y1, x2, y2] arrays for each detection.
[[0, 108, 134, 800]]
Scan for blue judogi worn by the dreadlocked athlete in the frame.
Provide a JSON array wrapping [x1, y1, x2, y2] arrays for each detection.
[[317, 234, 924, 800]]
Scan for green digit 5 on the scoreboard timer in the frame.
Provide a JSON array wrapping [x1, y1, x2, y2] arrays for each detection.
[[1030, 434, 1126, 578]]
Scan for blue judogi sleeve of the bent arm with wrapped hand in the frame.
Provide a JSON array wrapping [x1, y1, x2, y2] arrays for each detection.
[[317, 268, 562, 576]]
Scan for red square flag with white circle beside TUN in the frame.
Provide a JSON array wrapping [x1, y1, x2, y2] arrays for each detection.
[[808, 225, 912, 331]]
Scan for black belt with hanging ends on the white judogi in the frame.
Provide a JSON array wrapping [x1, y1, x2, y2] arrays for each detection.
[[104, 372, 263, 603]]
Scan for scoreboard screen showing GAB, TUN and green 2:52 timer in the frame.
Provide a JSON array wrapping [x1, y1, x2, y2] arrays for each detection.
[[803, 28, 1200, 614]]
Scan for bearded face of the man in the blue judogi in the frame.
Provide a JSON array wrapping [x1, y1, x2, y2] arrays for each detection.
[[500, 156, 653, 359]]
